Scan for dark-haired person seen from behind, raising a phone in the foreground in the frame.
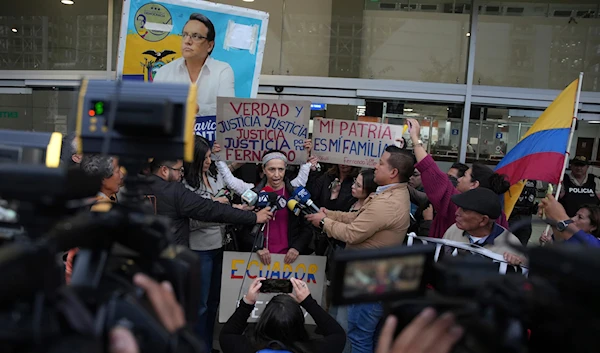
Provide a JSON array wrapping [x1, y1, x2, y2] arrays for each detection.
[[219, 278, 346, 353]]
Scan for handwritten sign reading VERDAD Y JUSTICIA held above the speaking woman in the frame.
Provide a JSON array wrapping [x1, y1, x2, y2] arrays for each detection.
[[217, 97, 310, 164]]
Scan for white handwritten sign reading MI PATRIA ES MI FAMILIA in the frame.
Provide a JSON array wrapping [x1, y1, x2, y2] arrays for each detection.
[[312, 118, 404, 168]]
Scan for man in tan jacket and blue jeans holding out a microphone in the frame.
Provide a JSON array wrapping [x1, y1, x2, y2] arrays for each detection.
[[306, 146, 414, 353]]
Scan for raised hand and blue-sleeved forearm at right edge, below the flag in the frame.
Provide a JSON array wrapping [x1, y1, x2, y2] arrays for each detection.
[[539, 195, 600, 248]]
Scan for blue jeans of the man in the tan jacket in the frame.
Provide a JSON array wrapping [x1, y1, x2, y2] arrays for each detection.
[[348, 303, 383, 353]]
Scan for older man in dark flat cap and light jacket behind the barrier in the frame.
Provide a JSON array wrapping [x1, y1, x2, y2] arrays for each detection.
[[444, 188, 525, 265]]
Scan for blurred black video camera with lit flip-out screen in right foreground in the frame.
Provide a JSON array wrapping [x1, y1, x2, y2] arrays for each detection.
[[332, 236, 600, 353]]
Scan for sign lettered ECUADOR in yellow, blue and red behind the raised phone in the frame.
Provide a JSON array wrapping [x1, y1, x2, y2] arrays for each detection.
[[219, 251, 327, 325]]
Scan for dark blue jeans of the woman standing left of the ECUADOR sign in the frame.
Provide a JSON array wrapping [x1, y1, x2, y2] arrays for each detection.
[[194, 248, 223, 353]]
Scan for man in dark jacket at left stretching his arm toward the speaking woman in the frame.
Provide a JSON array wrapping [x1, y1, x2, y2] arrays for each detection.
[[145, 160, 273, 246]]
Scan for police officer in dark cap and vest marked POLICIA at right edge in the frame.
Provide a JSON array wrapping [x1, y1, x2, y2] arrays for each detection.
[[559, 156, 600, 217]]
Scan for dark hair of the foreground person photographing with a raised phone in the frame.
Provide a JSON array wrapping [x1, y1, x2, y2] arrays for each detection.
[[253, 294, 309, 353]]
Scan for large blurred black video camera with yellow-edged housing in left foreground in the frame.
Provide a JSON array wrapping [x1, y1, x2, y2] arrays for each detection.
[[0, 81, 202, 353]]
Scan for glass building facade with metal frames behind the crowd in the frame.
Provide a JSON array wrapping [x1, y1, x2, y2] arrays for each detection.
[[0, 0, 600, 164]]
